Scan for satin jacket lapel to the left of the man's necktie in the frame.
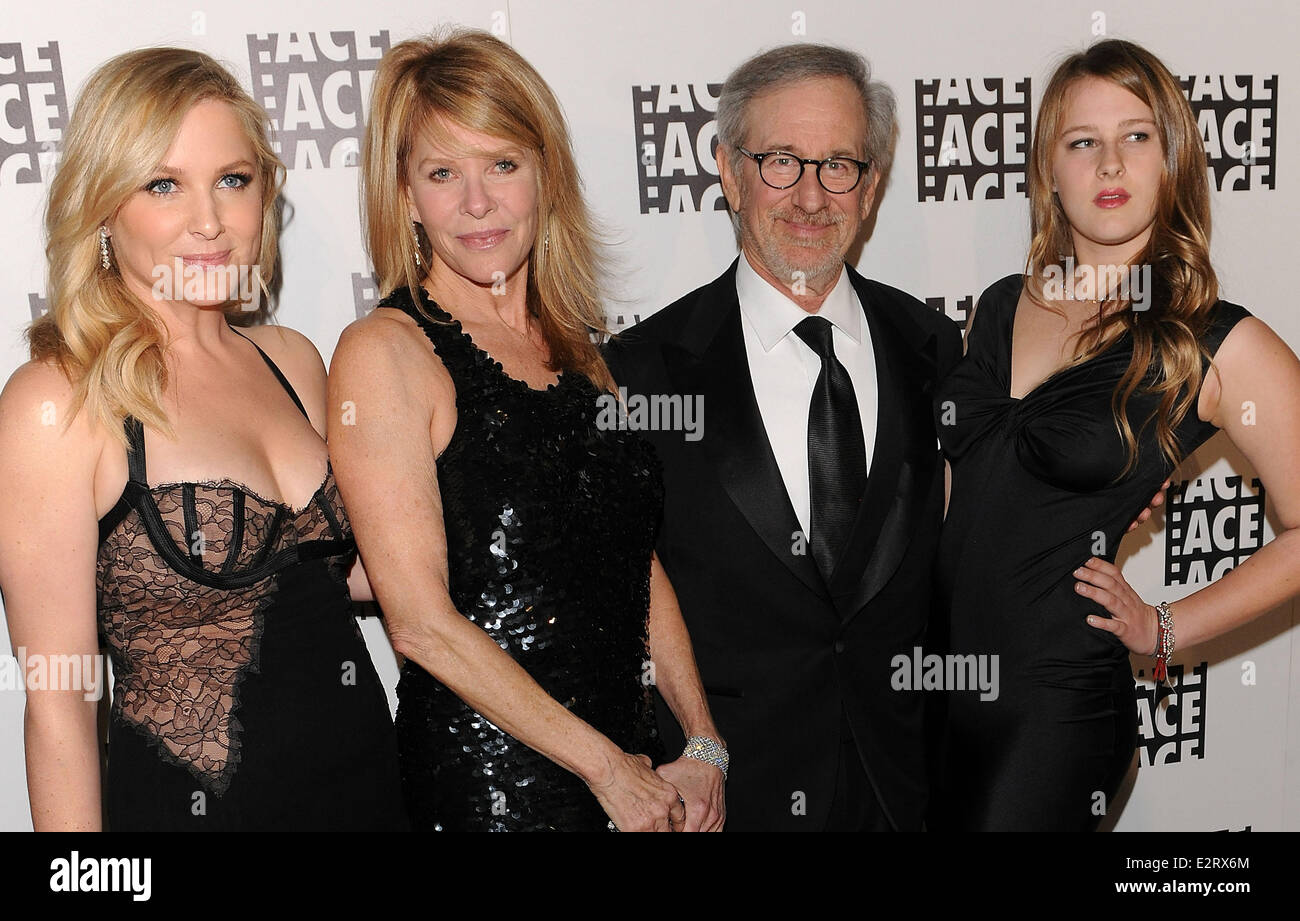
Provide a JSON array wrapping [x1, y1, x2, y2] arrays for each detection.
[[664, 283, 827, 598]]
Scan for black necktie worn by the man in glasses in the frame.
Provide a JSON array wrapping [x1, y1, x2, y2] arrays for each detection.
[[794, 316, 867, 583]]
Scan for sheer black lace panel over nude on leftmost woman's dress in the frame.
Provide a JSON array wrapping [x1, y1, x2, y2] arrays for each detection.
[[98, 471, 355, 795]]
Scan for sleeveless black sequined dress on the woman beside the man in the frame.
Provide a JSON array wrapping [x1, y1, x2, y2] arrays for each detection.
[[380, 287, 663, 831]]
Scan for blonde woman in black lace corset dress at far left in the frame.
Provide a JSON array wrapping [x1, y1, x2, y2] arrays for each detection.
[[0, 48, 407, 831]]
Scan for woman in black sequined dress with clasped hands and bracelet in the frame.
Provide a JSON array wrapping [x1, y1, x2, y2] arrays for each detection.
[[329, 33, 723, 830]]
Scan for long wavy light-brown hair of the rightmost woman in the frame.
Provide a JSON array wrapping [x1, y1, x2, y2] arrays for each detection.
[[1024, 39, 1218, 477]]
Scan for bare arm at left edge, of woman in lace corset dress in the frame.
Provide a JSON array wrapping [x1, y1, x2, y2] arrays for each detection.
[[0, 362, 105, 831]]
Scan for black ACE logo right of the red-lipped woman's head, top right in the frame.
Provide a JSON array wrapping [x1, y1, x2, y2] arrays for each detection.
[[1179, 74, 1278, 191]]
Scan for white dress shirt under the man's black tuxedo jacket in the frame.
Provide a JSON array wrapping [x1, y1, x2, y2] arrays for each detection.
[[736, 252, 878, 539]]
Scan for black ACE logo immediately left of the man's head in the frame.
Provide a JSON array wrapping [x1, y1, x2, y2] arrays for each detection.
[[632, 83, 727, 215]]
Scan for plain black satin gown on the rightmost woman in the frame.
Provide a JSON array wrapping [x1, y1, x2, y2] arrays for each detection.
[[930, 274, 1249, 831]]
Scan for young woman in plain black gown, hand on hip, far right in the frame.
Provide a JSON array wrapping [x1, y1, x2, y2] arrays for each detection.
[[933, 40, 1300, 830]]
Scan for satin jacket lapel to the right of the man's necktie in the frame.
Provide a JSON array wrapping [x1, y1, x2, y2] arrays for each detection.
[[831, 278, 935, 619]]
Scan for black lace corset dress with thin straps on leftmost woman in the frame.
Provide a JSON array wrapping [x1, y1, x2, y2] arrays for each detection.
[[98, 333, 407, 831]]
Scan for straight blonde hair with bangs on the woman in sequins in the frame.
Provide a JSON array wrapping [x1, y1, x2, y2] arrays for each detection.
[[360, 29, 614, 390]]
